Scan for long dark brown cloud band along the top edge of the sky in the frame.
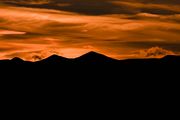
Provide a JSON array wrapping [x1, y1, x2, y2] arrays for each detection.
[[2, 0, 180, 15]]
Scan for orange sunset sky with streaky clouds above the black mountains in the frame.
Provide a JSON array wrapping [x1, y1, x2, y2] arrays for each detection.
[[0, 0, 180, 61]]
